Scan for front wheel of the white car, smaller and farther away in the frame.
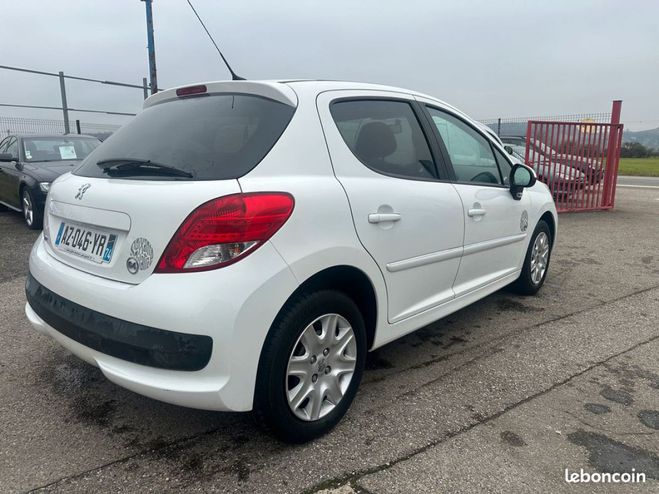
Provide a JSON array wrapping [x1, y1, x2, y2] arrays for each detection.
[[511, 220, 553, 295]]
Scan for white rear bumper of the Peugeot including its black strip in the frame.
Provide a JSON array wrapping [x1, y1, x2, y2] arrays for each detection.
[[25, 236, 298, 411]]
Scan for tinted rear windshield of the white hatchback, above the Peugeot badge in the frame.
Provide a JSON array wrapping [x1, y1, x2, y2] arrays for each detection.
[[74, 94, 295, 180]]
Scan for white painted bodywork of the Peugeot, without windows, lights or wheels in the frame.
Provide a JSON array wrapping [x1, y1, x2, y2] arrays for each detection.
[[26, 81, 557, 411]]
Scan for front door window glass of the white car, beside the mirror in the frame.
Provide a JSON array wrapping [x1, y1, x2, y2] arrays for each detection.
[[428, 108, 502, 184]]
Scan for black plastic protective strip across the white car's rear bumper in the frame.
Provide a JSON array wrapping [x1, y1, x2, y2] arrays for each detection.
[[25, 274, 213, 371]]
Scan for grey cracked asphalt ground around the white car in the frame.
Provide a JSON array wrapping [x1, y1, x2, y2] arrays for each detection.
[[0, 188, 659, 493]]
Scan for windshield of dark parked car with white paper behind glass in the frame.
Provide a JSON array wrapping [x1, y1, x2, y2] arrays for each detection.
[[23, 136, 101, 163]]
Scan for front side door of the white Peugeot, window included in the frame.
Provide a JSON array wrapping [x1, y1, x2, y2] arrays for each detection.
[[425, 104, 530, 296]]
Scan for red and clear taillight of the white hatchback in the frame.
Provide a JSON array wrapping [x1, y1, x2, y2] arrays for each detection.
[[155, 192, 295, 273]]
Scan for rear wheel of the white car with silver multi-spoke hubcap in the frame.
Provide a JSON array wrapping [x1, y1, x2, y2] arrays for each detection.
[[253, 290, 367, 443]]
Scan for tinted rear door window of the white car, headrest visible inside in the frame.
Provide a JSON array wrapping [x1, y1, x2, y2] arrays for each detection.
[[330, 100, 436, 179]]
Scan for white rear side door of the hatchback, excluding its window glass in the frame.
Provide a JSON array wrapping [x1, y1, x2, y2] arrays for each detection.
[[317, 91, 464, 322]]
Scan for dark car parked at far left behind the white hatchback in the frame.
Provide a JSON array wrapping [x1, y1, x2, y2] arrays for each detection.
[[0, 135, 101, 230]]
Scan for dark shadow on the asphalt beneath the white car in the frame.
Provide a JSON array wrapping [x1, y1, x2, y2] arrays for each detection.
[[35, 284, 544, 454]]
